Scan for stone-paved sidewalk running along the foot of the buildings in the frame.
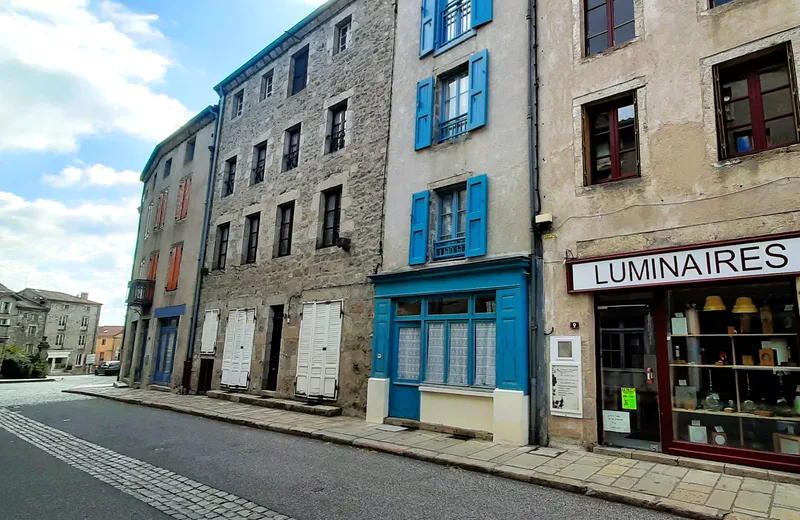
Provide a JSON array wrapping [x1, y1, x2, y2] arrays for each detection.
[[64, 387, 800, 520]]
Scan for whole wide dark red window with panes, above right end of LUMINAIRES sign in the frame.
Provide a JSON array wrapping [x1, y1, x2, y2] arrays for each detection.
[[716, 46, 798, 159]]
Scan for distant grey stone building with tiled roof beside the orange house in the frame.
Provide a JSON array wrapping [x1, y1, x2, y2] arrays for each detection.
[[19, 288, 103, 372]]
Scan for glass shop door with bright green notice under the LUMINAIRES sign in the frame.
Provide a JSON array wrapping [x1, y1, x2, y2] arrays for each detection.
[[596, 295, 661, 451]]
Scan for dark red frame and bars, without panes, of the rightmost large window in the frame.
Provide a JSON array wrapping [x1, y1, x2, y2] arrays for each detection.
[[714, 44, 800, 159]]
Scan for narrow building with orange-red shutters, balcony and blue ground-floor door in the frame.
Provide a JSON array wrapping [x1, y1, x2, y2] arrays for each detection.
[[120, 106, 217, 389]]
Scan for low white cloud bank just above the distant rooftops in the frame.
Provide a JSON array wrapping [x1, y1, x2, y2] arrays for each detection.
[[0, 192, 139, 325]]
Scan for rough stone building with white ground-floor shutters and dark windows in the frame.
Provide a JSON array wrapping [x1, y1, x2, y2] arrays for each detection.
[[193, 0, 394, 414]]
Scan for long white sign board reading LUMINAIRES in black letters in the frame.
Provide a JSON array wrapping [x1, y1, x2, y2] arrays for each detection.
[[570, 237, 800, 292]]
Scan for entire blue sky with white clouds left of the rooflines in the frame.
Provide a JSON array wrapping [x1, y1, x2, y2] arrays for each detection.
[[0, 0, 324, 325]]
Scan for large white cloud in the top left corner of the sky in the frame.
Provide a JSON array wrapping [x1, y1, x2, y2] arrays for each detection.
[[0, 0, 191, 152]]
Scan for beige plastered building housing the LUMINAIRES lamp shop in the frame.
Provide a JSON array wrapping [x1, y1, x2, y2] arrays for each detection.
[[537, 0, 800, 470]]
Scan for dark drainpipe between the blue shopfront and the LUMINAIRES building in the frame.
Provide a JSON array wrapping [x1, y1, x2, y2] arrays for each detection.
[[526, 0, 547, 445]]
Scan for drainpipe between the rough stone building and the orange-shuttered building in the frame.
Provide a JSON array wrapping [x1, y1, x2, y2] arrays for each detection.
[[181, 93, 225, 394]]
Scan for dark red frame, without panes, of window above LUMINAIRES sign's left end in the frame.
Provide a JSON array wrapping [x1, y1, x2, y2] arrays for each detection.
[[584, 92, 640, 185]]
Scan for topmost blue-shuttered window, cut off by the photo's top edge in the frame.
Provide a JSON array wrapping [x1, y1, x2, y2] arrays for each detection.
[[419, 0, 493, 57]]
